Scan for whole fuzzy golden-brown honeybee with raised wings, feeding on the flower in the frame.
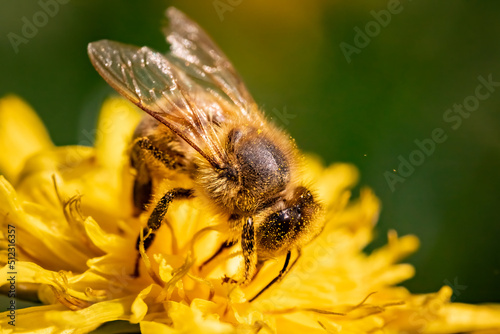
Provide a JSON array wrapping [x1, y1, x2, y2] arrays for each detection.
[[88, 8, 323, 299]]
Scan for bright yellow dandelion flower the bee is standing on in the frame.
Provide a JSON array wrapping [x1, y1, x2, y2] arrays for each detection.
[[0, 96, 500, 333]]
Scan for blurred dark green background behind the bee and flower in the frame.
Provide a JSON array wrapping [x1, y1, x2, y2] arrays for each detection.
[[0, 0, 500, 302]]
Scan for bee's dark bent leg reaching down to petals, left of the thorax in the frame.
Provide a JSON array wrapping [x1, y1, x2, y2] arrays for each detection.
[[133, 188, 193, 277]]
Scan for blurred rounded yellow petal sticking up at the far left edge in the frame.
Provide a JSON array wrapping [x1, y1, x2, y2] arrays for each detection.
[[0, 95, 53, 182]]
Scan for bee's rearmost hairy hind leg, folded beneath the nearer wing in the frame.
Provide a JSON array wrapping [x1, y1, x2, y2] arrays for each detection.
[[130, 137, 182, 216]]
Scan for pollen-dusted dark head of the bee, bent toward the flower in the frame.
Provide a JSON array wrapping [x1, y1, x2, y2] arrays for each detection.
[[256, 187, 323, 259]]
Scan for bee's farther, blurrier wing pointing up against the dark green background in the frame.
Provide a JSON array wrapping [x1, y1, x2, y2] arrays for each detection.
[[163, 7, 263, 121]]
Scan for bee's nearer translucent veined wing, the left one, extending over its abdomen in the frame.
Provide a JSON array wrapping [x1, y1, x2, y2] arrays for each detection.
[[88, 40, 234, 167]]
